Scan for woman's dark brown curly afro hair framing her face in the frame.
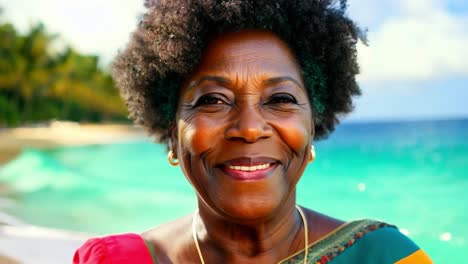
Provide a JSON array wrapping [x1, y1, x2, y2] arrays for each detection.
[[113, 0, 365, 143]]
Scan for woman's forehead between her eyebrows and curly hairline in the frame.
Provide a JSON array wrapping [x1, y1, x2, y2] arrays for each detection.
[[194, 30, 299, 75]]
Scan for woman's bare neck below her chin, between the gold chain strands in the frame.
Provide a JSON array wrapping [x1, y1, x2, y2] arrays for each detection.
[[196, 195, 304, 263]]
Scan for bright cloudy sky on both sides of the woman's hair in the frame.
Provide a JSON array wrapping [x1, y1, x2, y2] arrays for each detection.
[[0, 0, 468, 120]]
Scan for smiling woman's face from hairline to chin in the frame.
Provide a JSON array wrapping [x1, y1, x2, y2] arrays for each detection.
[[176, 31, 313, 220]]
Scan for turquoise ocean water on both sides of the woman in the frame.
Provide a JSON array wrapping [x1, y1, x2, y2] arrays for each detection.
[[0, 119, 468, 263]]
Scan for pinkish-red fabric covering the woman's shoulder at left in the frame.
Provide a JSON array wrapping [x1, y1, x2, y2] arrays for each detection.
[[73, 234, 153, 264]]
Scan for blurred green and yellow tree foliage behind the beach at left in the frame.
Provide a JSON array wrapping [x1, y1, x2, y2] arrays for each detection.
[[0, 10, 127, 127]]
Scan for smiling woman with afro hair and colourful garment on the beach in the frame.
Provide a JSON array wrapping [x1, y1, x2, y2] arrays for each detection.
[[74, 0, 431, 264]]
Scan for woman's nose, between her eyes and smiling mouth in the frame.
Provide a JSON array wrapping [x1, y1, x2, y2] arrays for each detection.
[[225, 107, 273, 143]]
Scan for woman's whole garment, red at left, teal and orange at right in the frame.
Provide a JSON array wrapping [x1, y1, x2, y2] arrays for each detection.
[[73, 220, 432, 264]]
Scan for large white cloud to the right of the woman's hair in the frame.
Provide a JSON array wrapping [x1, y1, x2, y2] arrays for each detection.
[[358, 0, 468, 81]]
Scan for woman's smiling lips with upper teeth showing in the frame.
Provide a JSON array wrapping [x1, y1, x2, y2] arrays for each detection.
[[221, 158, 278, 181]]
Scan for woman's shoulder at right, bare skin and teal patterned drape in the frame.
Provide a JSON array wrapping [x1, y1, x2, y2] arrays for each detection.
[[299, 212, 432, 264]]
